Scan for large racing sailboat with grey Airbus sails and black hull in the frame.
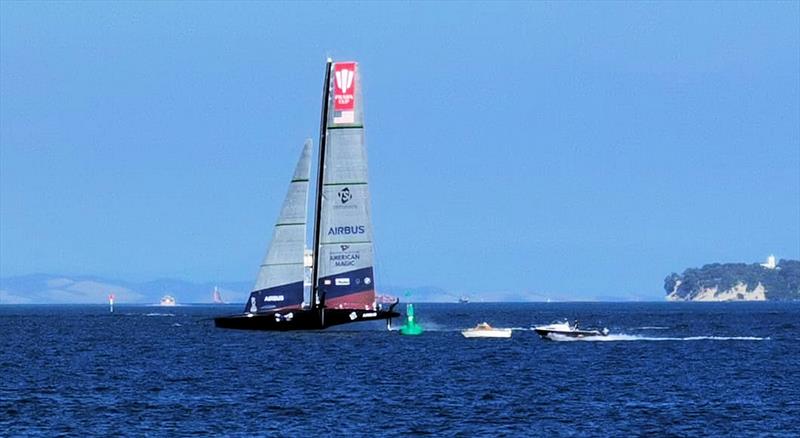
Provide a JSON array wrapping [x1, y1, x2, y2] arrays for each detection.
[[214, 59, 400, 330]]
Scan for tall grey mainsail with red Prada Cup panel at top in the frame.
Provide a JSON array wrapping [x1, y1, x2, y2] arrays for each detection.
[[314, 62, 375, 310]]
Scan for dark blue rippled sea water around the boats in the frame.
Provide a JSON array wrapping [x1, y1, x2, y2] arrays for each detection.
[[0, 303, 800, 436]]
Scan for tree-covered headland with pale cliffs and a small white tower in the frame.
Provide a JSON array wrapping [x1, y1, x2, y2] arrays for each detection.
[[664, 256, 800, 301]]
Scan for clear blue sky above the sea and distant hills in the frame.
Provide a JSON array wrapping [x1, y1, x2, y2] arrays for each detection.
[[0, 2, 800, 299]]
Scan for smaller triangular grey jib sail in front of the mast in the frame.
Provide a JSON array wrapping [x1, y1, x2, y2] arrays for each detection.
[[244, 140, 311, 313]]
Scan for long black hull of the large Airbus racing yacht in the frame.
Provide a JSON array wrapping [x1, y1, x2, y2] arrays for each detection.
[[214, 309, 400, 332]]
